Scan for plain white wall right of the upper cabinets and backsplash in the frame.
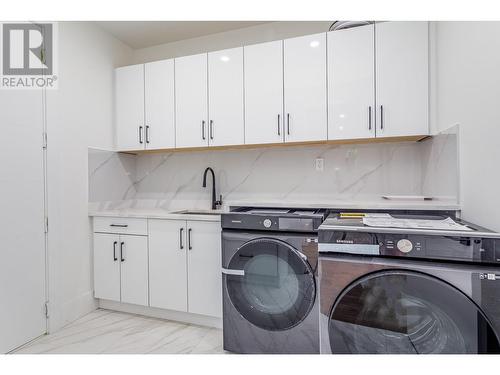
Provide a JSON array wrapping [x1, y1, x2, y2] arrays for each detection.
[[436, 22, 500, 231]]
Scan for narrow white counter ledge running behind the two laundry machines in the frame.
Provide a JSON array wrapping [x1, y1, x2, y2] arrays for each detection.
[[224, 198, 460, 211]]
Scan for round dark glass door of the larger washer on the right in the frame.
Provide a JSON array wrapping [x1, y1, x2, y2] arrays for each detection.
[[329, 271, 499, 354]]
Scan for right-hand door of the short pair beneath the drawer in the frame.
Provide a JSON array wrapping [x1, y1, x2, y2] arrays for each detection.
[[118, 235, 148, 306]]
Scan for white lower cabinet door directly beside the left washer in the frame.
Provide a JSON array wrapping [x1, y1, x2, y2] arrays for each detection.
[[187, 221, 222, 317]]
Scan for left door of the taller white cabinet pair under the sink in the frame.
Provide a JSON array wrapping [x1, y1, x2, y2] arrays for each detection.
[[149, 220, 187, 312]]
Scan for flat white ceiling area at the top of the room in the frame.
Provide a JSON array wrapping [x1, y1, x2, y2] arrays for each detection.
[[96, 21, 272, 49]]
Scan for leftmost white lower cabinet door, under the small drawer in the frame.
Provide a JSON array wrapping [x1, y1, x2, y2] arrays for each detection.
[[94, 233, 120, 301]]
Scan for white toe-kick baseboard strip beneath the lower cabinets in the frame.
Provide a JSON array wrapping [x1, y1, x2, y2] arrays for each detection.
[[99, 299, 222, 328]]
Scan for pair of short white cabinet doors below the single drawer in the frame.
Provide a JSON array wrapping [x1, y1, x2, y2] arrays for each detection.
[[94, 233, 149, 306]]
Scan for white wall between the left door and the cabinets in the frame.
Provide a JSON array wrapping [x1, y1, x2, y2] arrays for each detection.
[[46, 22, 132, 332]]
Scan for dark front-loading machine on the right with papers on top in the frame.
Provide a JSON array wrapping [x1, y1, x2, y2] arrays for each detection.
[[319, 215, 500, 354]]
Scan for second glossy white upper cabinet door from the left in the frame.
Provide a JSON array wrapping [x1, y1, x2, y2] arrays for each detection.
[[144, 59, 175, 149]]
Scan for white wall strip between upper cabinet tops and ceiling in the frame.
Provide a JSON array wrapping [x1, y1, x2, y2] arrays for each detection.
[[134, 21, 332, 64]]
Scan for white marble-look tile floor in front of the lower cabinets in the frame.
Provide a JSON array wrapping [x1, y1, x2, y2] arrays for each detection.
[[14, 309, 224, 354]]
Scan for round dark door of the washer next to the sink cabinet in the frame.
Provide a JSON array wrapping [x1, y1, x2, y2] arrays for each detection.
[[226, 238, 316, 331]]
